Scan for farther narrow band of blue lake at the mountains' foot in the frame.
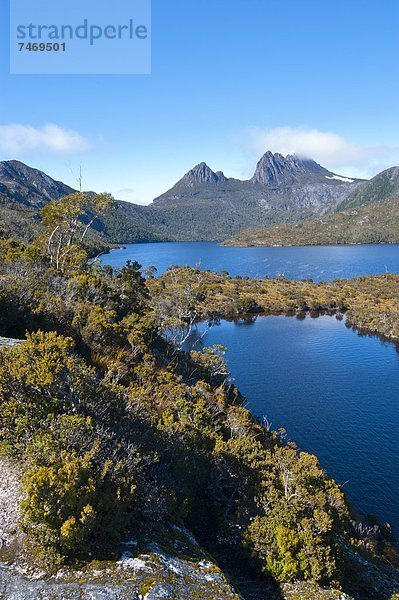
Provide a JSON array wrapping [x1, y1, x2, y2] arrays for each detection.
[[102, 242, 399, 281]]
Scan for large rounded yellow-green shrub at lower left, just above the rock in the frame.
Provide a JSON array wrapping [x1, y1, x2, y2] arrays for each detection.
[[21, 415, 136, 562]]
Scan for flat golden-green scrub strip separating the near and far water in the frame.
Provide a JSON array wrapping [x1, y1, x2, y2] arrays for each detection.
[[148, 267, 399, 341]]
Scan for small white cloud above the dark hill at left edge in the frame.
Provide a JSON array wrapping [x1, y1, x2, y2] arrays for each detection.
[[0, 123, 90, 157]]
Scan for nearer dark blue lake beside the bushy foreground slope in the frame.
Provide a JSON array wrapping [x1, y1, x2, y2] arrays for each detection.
[[204, 316, 399, 534]]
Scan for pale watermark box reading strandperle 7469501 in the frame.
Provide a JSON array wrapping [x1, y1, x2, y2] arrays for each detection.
[[10, 0, 151, 75]]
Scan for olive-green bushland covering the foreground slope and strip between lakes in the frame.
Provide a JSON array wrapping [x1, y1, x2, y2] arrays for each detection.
[[0, 236, 399, 596]]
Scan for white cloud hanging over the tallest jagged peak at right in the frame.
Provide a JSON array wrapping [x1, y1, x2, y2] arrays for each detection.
[[244, 127, 399, 177]]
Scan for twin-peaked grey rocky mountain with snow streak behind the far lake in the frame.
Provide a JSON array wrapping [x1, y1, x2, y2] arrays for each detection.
[[148, 152, 363, 240]]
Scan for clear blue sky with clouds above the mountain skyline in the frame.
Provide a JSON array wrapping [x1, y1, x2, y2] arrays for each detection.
[[0, 0, 399, 203]]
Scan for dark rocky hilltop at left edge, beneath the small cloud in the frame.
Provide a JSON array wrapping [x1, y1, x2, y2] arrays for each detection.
[[0, 160, 74, 208]]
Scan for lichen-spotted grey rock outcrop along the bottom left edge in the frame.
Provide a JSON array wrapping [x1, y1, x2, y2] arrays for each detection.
[[0, 527, 239, 600]]
